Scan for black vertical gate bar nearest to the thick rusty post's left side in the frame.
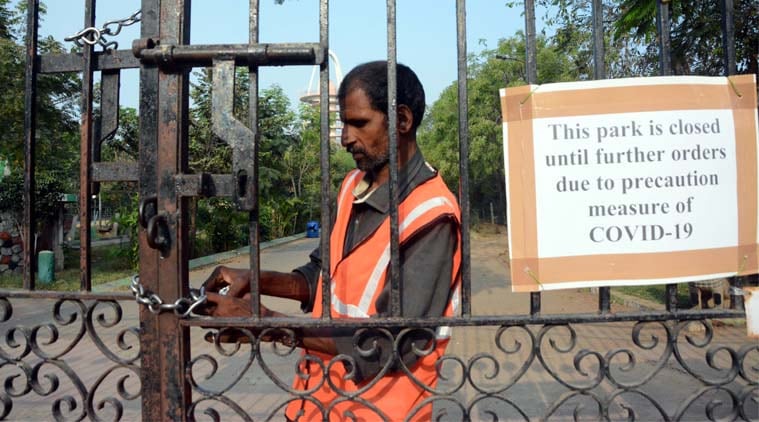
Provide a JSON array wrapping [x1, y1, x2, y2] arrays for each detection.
[[79, 0, 96, 291]]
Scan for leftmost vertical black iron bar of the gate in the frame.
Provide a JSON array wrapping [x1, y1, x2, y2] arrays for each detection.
[[22, 0, 40, 290]]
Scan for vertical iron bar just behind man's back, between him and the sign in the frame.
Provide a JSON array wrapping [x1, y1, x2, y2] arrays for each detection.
[[456, 0, 472, 317]]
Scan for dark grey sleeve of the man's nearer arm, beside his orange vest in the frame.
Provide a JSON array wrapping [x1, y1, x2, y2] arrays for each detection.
[[335, 220, 458, 382]]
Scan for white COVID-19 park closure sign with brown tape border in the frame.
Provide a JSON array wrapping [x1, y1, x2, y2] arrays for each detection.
[[501, 75, 759, 291]]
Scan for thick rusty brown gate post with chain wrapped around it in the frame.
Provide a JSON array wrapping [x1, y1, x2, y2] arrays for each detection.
[[139, 0, 190, 420]]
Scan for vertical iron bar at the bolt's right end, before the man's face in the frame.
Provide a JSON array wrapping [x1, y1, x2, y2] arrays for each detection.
[[319, 0, 339, 319]]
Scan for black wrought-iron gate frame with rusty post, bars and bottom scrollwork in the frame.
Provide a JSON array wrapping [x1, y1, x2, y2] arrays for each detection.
[[0, 0, 759, 420]]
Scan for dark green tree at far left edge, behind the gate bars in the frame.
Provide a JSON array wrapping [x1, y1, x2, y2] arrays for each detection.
[[0, 0, 81, 258]]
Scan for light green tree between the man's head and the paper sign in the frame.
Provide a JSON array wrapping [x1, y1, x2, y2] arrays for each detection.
[[419, 33, 579, 222]]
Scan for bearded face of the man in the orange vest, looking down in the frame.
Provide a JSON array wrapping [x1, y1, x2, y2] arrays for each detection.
[[340, 88, 389, 173]]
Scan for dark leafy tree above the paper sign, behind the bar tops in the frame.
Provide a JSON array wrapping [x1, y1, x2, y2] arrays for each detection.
[[539, 0, 759, 77]]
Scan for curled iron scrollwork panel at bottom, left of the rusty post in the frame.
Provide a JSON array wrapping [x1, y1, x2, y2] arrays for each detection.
[[0, 298, 141, 421]]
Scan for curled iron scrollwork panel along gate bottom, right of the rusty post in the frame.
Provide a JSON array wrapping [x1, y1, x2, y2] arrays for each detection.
[[183, 321, 759, 421]]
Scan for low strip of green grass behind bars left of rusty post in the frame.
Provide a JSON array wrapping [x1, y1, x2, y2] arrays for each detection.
[[0, 245, 135, 291]]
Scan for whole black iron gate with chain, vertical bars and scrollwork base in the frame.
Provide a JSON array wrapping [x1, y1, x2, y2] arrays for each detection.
[[0, 0, 759, 420]]
